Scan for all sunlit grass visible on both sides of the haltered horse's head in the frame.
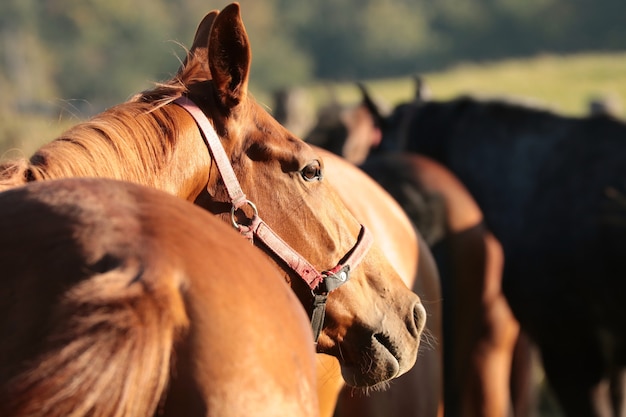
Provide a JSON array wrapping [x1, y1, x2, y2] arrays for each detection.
[[0, 52, 626, 160]]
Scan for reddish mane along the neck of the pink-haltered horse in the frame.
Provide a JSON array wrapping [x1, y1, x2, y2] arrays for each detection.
[[0, 53, 205, 191]]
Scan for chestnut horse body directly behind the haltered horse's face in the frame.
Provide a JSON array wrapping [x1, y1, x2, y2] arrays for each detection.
[[318, 149, 443, 417]]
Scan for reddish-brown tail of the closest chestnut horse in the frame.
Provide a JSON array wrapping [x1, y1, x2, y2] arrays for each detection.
[[0, 267, 188, 417]]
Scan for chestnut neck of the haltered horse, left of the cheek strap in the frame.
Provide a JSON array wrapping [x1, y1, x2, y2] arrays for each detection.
[[27, 102, 209, 199]]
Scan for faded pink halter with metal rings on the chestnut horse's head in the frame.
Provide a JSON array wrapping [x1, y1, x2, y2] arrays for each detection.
[[174, 96, 373, 343]]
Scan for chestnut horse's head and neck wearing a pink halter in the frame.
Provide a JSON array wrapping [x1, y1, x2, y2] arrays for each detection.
[[0, 3, 425, 394]]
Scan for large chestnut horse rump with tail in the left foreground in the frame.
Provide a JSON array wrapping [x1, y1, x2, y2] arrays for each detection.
[[0, 178, 318, 417]]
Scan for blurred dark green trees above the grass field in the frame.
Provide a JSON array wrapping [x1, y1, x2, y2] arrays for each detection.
[[0, 0, 626, 116]]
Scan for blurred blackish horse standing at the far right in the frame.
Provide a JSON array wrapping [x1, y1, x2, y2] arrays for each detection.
[[356, 84, 626, 416]]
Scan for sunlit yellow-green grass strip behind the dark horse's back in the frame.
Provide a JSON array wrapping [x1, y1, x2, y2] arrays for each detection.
[[300, 52, 626, 116]]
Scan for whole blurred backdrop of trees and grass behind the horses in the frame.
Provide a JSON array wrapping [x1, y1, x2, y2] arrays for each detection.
[[0, 0, 626, 156]]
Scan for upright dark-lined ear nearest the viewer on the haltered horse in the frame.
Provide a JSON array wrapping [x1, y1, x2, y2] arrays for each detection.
[[209, 3, 251, 108]]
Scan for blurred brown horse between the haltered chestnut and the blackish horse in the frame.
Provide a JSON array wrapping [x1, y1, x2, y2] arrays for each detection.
[[310, 88, 519, 417]]
